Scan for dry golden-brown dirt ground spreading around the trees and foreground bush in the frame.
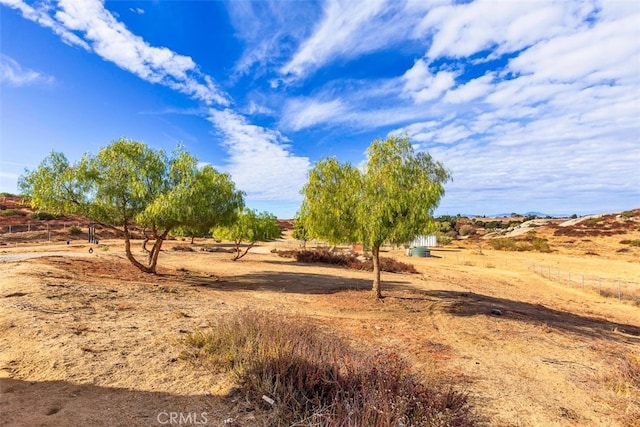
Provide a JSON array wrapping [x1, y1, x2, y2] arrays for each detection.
[[0, 226, 640, 426]]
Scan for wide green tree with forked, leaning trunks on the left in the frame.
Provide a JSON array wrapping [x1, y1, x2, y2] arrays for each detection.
[[19, 138, 244, 273]]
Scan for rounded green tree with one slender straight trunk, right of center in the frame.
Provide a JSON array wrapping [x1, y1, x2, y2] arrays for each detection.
[[301, 136, 451, 298]]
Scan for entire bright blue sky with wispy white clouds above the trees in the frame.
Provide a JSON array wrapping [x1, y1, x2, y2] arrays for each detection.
[[0, 0, 640, 218]]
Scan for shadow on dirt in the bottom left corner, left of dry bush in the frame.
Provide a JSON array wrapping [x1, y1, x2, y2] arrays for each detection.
[[0, 378, 247, 427]]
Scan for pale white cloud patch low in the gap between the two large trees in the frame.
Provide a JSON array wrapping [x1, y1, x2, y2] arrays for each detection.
[[209, 109, 310, 201]]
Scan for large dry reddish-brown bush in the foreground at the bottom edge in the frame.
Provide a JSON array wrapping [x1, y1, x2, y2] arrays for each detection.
[[182, 311, 477, 426]]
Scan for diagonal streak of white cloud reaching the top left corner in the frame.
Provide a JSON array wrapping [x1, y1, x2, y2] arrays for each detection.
[[0, 0, 230, 106]]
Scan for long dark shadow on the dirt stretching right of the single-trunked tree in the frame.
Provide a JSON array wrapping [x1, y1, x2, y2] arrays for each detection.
[[424, 290, 640, 343]]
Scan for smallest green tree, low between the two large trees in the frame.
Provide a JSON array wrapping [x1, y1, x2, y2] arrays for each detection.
[[213, 208, 282, 261]]
